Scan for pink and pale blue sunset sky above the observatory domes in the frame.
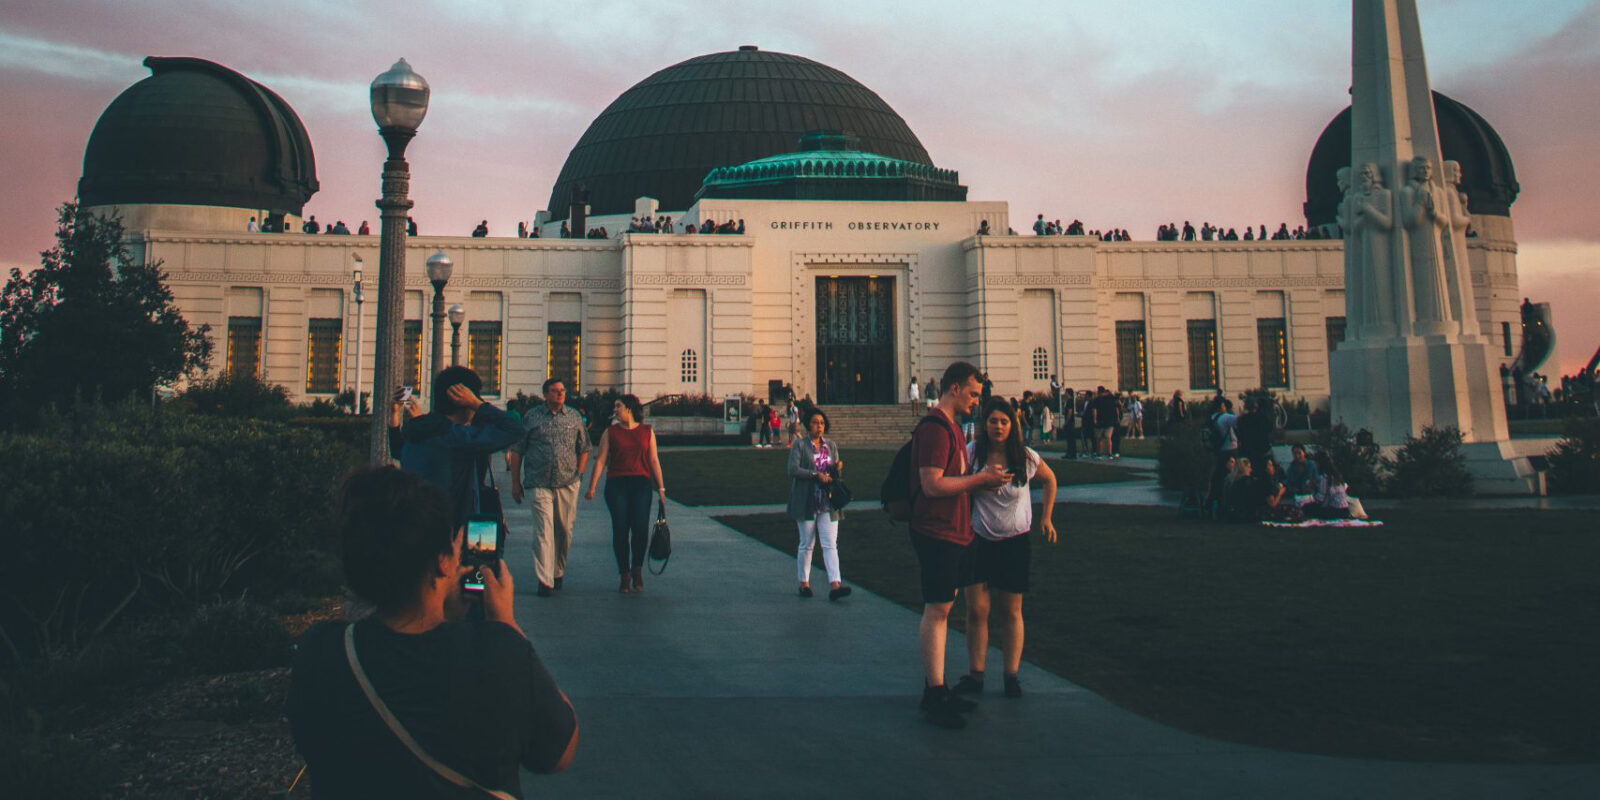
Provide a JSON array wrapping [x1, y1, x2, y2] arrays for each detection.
[[0, 0, 1600, 374]]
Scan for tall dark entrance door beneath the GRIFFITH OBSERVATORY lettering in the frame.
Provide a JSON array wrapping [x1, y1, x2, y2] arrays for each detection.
[[816, 277, 898, 405]]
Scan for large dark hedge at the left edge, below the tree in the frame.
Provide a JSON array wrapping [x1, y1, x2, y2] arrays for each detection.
[[0, 403, 360, 658]]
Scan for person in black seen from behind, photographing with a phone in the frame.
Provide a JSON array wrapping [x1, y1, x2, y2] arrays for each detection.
[[286, 467, 578, 798]]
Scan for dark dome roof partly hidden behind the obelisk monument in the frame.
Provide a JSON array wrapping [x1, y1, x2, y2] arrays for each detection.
[[1306, 91, 1522, 226]]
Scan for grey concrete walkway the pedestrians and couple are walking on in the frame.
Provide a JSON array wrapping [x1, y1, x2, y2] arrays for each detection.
[[501, 467, 1600, 800]]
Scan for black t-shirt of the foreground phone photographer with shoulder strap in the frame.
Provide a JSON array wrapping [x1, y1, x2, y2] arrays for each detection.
[[288, 621, 578, 800]]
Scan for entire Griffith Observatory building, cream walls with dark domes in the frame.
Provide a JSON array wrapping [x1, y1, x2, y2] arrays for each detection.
[[78, 46, 1520, 406]]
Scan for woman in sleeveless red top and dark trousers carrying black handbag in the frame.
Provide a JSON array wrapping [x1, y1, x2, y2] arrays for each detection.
[[584, 395, 667, 594]]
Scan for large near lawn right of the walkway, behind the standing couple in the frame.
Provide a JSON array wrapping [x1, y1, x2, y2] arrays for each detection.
[[720, 504, 1600, 763]]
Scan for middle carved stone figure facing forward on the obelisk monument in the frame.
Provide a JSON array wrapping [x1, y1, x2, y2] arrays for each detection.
[[1400, 155, 1454, 334]]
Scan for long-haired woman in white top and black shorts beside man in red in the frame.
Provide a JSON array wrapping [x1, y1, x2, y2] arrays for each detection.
[[950, 400, 1056, 698]]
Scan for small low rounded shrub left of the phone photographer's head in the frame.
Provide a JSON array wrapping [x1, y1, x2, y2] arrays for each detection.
[[182, 600, 290, 672]]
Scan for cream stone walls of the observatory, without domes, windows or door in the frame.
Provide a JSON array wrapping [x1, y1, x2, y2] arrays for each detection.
[[123, 200, 1520, 405]]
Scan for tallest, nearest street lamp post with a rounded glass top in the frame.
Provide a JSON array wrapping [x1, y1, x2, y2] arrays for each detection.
[[368, 59, 429, 464]]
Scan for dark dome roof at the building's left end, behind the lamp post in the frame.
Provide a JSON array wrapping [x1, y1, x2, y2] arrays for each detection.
[[78, 56, 318, 216]]
